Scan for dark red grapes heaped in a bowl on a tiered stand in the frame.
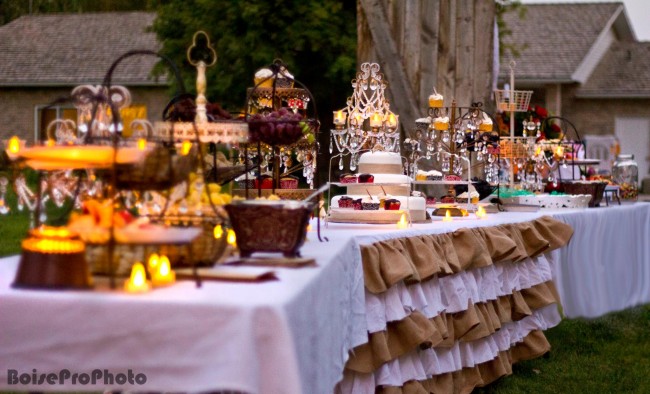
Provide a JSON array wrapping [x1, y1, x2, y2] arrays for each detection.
[[248, 108, 311, 145]]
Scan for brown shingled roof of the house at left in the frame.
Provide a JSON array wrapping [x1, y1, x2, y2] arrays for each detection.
[[0, 12, 165, 86]]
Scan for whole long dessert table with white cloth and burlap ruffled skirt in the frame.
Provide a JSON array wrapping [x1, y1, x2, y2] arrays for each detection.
[[0, 203, 650, 393]]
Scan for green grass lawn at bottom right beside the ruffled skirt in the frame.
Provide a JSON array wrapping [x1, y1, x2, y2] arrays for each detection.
[[475, 305, 650, 394]]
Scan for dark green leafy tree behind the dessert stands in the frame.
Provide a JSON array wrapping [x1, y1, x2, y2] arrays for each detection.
[[153, 0, 356, 119]]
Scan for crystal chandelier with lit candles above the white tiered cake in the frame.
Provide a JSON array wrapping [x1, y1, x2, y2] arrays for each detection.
[[329, 63, 400, 171]]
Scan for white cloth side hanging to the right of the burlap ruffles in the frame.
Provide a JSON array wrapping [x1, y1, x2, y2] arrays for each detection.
[[553, 203, 650, 317]]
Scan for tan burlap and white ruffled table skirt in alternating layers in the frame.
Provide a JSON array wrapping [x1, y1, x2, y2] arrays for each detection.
[[336, 216, 573, 393]]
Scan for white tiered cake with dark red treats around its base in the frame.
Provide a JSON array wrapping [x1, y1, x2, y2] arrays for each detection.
[[329, 152, 426, 223]]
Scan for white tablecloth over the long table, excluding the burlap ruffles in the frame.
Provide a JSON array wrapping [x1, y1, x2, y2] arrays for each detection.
[[0, 203, 650, 393]]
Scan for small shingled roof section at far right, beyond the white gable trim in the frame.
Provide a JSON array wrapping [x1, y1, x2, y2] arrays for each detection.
[[576, 42, 650, 98]]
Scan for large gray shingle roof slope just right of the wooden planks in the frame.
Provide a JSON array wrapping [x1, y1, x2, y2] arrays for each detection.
[[499, 2, 622, 81]]
